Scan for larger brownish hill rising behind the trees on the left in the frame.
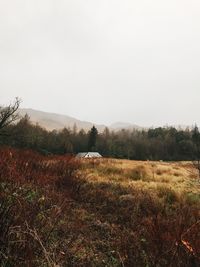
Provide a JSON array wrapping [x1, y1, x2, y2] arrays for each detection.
[[19, 108, 106, 132]]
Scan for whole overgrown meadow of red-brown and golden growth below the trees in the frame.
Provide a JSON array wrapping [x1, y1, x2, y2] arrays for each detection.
[[0, 148, 200, 267]]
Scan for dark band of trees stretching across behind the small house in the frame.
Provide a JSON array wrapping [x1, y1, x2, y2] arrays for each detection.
[[0, 98, 200, 161]]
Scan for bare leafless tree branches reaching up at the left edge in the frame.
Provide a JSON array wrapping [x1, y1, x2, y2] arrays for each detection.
[[0, 97, 21, 131]]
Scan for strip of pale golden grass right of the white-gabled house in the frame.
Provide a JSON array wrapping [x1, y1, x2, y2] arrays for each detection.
[[81, 159, 200, 194]]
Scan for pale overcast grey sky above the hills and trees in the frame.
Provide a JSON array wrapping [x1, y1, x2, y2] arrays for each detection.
[[0, 0, 200, 126]]
